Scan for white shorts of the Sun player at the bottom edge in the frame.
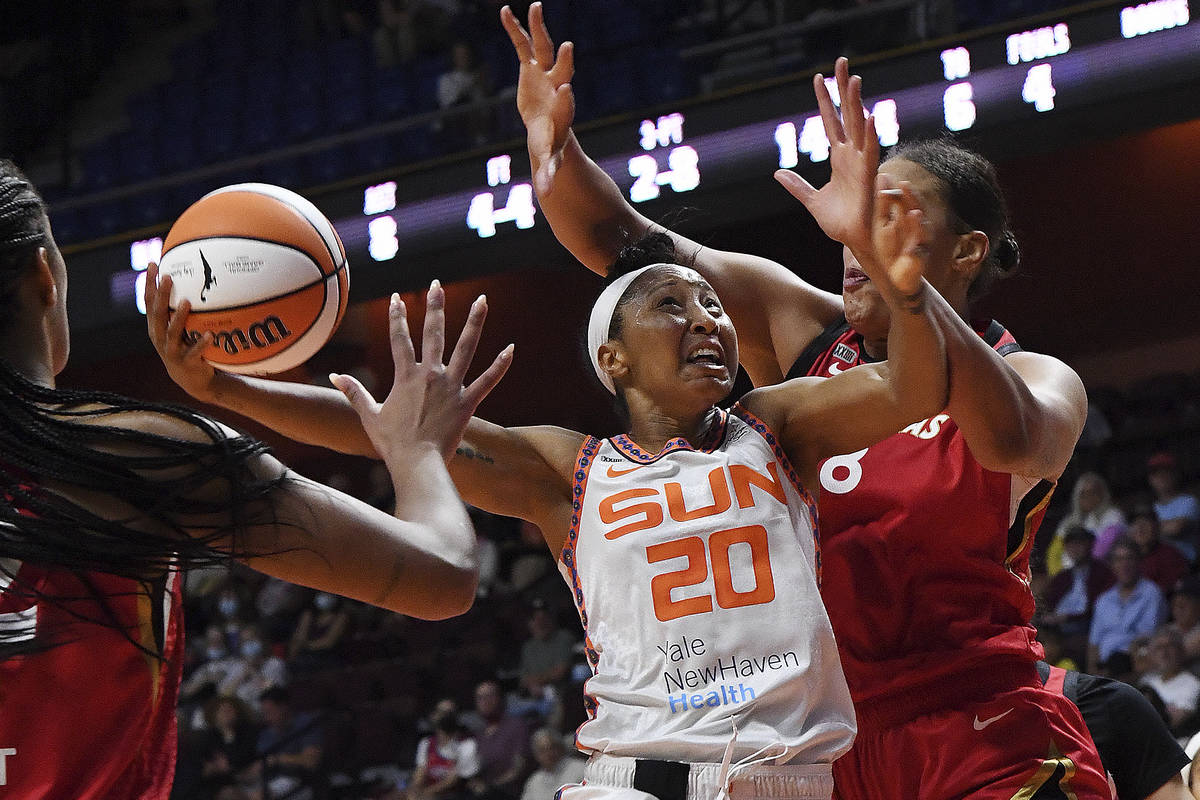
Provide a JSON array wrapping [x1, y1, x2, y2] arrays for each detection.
[[556, 753, 833, 800]]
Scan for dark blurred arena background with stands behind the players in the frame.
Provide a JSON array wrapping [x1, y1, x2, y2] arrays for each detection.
[[0, 0, 1200, 799]]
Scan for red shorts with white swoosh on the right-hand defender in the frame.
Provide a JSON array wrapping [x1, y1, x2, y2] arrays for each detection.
[[833, 681, 1112, 800]]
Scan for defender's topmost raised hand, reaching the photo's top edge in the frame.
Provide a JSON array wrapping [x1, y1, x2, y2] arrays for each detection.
[[500, 2, 575, 197]]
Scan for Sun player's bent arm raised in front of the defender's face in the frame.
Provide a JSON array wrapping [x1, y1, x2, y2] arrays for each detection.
[[743, 176, 947, 472]]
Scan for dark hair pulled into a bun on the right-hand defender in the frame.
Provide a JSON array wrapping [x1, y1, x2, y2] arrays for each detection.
[[888, 138, 1021, 300]]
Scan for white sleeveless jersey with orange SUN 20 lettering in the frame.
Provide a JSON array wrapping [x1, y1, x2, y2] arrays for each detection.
[[559, 407, 856, 763]]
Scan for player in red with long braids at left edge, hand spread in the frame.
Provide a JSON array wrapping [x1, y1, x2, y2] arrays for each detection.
[[0, 161, 509, 800]]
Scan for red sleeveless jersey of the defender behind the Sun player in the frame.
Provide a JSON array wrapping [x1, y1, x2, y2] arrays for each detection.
[[788, 320, 1054, 709]]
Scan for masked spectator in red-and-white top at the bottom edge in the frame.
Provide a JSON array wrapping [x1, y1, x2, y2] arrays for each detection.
[[403, 699, 479, 800]]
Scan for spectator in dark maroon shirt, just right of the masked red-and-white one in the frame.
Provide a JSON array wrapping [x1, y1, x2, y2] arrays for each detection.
[[468, 680, 529, 800]]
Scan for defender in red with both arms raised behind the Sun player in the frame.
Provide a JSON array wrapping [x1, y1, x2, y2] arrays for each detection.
[[502, 4, 1109, 800]]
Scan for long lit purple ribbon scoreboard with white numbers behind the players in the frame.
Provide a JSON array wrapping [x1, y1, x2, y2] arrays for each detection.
[[100, 0, 1200, 326]]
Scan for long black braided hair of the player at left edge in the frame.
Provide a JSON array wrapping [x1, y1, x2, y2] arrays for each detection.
[[0, 160, 287, 658]]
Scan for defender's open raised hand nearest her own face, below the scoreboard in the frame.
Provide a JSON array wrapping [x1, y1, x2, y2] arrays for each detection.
[[775, 58, 880, 255]]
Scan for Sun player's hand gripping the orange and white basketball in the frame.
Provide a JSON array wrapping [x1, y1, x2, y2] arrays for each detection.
[[143, 264, 217, 402]]
